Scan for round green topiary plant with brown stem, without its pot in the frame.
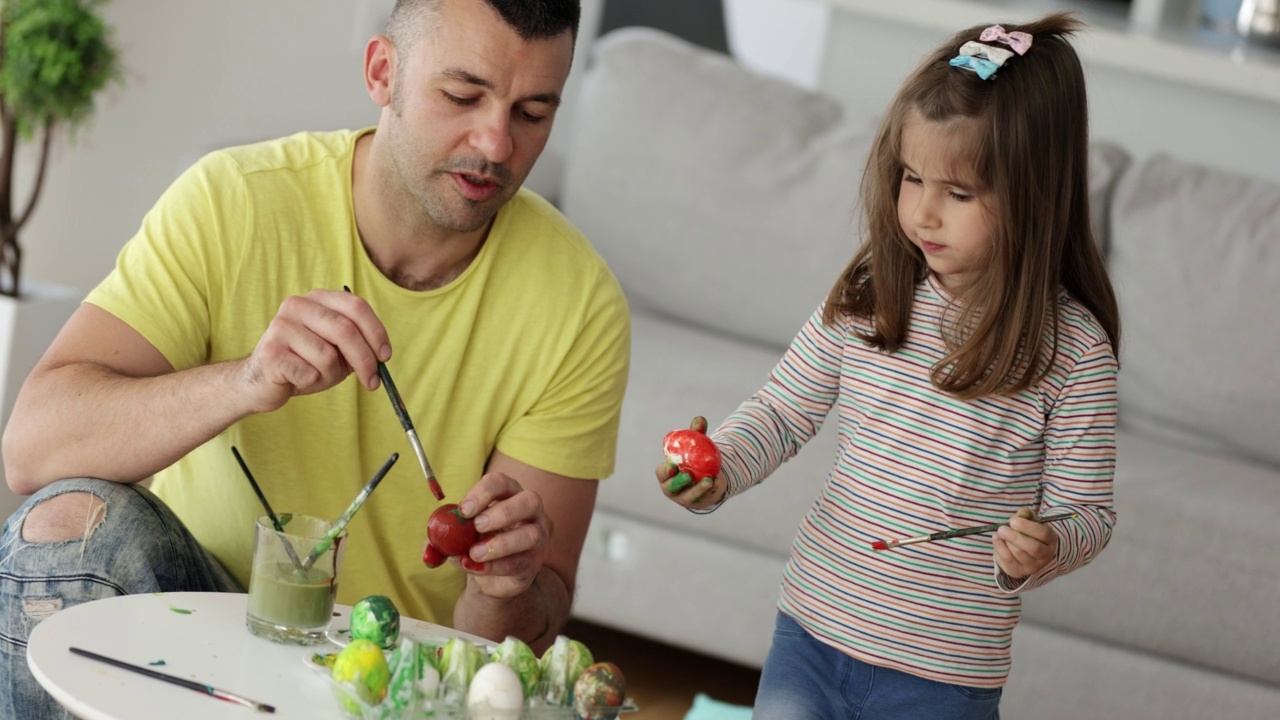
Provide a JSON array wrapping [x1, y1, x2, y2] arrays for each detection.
[[0, 0, 120, 297]]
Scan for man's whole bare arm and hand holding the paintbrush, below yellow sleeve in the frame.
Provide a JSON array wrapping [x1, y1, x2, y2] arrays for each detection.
[[4, 291, 390, 495]]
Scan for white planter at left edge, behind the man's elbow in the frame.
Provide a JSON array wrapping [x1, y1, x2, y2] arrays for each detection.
[[0, 282, 84, 523]]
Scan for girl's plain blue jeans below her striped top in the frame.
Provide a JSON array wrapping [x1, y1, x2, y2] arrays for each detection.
[[751, 612, 1001, 720]]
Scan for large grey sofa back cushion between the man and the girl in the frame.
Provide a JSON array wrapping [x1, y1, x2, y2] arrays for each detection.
[[561, 28, 874, 347]]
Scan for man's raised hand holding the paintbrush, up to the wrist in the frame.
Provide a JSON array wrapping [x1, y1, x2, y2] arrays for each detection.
[[242, 290, 392, 413]]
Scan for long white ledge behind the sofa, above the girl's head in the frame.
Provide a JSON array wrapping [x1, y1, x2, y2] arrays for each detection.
[[822, 0, 1280, 102]]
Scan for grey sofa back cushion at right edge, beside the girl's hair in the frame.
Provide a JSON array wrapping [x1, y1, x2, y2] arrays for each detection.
[[1110, 156, 1280, 466]]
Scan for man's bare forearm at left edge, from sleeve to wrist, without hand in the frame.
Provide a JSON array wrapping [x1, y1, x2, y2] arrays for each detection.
[[4, 304, 257, 495]]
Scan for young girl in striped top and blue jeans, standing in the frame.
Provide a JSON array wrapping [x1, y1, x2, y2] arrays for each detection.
[[658, 14, 1120, 720]]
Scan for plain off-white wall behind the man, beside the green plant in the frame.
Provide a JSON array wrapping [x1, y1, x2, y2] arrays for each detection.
[[16, 0, 599, 291]]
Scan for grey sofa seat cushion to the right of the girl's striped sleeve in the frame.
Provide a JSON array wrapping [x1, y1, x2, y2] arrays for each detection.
[[1015, 432, 1280, 684]]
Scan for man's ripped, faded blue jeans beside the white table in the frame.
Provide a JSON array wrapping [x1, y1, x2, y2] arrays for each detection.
[[0, 478, 244, 720]]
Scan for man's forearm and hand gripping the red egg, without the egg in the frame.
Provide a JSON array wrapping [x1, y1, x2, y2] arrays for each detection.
[[453, 451, 598, 655]]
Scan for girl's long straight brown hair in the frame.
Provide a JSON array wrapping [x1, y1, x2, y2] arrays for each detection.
[[823, 13, 1120, 398]]
